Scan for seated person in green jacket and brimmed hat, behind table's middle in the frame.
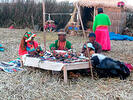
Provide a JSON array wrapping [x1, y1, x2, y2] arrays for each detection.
[[49, 32, 72, 50]]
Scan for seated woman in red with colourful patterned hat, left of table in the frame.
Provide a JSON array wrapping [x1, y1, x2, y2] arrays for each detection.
[[19, 32, 42, 57]]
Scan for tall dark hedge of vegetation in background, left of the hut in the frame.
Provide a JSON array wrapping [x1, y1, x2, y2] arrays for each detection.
[[0, 0, 73, 29]]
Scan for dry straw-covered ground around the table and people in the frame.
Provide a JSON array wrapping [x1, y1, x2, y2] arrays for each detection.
[[0, 29, 133, 100]]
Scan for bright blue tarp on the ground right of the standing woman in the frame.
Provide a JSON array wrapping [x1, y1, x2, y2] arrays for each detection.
[[109, 32, 133, 41]]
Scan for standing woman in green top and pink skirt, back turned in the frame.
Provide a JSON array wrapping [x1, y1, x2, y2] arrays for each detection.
[[93, 8, 111, 51]]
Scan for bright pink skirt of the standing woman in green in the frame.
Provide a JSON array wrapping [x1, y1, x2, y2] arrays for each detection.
[[95, 26, 111, 51]]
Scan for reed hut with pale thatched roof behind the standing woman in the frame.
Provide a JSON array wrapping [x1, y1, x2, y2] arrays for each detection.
[[67, 0, 131, 33]]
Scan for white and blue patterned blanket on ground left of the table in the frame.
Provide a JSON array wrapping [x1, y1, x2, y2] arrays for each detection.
[[0, 58, 23, 73]]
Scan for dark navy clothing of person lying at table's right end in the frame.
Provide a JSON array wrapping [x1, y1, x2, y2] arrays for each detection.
[[91, 55, 130, 80]]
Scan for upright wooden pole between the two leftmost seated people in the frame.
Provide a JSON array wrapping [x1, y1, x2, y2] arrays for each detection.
[[42, 0, 46, 51]]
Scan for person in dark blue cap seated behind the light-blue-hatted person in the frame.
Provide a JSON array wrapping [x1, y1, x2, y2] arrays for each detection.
[[82, 33, 102, 56]]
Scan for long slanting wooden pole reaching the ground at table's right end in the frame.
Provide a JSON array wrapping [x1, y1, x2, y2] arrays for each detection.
[[76, 4, 94, 79]]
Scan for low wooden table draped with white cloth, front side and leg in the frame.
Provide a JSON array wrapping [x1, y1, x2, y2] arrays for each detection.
[[23, 57, 89, 83]]
